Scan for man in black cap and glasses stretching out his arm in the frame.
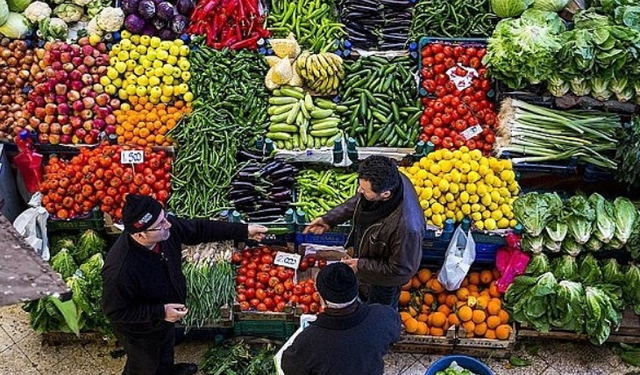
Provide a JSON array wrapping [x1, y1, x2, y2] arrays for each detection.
[[102, 194, 267, 375]]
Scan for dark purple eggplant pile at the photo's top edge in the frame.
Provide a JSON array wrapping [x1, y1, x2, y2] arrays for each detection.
[[340, 0, 411, 51]]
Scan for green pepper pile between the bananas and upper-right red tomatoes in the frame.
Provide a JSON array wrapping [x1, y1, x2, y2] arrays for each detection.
[[340, 56, 420, 147]]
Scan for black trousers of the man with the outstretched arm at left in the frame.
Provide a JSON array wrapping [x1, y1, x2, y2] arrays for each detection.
[[114, 324, 175, 375]]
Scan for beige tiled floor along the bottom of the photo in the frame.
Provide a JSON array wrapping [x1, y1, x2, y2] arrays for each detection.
[[0, 306, 640, 375]]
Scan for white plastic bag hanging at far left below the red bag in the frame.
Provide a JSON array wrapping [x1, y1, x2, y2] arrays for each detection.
[[13, 192, 50, 262]]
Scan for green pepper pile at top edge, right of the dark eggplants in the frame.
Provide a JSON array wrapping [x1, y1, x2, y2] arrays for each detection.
[[410, 0, 500, 40]]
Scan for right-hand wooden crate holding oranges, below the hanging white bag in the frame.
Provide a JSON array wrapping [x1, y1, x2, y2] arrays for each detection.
[[453, 324, 516, 358]]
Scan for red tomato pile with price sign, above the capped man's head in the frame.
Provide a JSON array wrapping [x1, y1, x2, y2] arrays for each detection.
[[40, 145, 171, 220]]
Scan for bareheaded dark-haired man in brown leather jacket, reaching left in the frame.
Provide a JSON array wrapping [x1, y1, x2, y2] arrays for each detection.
[[305, 155, 426, 307]]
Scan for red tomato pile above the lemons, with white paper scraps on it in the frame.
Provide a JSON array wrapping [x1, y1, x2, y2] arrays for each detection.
[[420, 43, 497, 155]]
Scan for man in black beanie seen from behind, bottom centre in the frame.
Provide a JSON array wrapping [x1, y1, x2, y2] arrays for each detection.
[[281, 263, 401, 375]]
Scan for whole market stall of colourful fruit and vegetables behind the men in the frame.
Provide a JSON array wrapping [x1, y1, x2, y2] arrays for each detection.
[[0, 0, 640, 374]]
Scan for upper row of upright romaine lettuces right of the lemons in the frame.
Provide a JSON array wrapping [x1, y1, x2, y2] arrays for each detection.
[[513, 192, 638, 256]]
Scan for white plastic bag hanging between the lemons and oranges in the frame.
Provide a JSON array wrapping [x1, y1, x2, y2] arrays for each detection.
[[438, 226, 476, 291]]
